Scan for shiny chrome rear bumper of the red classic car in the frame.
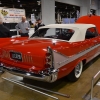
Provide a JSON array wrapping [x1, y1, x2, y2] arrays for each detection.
[[0, 66, 58, 83]]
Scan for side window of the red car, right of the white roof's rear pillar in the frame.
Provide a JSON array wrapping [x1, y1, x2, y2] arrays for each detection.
[[85, 27, 98, 39]]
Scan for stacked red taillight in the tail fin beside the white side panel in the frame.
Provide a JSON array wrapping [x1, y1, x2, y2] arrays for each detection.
[[45, 47, 53, 68]]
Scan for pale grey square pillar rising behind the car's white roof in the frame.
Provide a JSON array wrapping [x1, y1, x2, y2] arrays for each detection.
[[41, 0, 55, 25]]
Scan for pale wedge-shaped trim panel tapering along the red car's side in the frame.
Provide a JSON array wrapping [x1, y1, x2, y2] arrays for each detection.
[[53, 44, 100, 69]]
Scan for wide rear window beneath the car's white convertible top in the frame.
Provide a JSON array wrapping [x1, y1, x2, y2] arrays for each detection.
[[31, 28, 74, 41]]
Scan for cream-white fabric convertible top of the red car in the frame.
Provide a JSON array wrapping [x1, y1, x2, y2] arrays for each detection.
[[39, 24, 96, 42]]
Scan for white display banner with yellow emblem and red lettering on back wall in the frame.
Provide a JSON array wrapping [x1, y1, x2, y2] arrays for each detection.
[[0, 8, 25, 23]]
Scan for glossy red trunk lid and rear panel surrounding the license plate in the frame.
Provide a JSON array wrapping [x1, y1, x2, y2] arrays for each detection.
[[2, 38, 69, 71]]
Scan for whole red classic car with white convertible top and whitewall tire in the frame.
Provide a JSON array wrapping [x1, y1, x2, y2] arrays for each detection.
[[0, 15, 100, 82]]
